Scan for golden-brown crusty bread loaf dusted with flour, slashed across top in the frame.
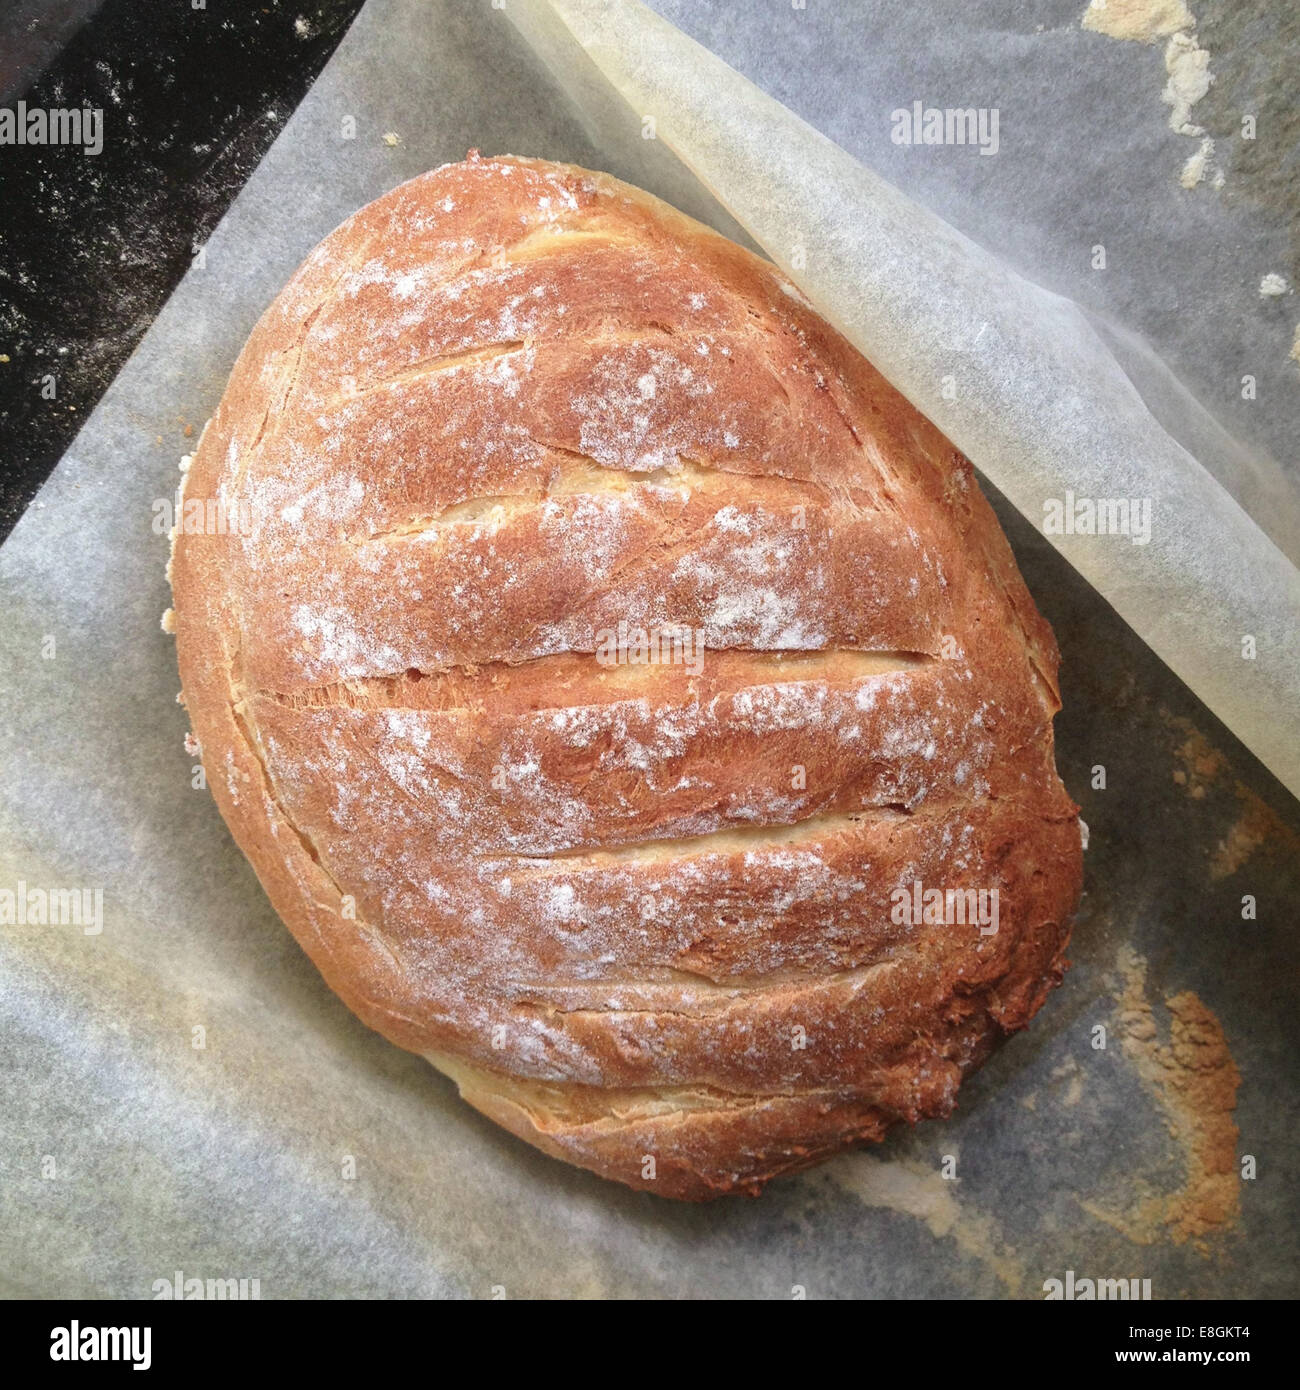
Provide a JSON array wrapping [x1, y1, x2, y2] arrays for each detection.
[[172, 156, 1080, 1198]]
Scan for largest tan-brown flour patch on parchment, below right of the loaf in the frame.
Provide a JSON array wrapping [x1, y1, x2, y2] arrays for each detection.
[[1082, 947, 1242, 1255]]
